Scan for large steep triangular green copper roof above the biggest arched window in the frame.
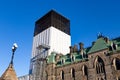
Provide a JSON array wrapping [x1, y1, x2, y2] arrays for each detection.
[[88, 38, 108, 54]]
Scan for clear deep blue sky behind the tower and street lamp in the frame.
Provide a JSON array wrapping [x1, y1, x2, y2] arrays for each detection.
[[0, 0, 120, 76]]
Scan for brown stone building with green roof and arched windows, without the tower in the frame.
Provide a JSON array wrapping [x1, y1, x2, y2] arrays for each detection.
[[43, 35, 120, 80]]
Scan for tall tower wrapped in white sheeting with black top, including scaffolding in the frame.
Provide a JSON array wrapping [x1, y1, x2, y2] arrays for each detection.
[[29, 10, 71, 80]]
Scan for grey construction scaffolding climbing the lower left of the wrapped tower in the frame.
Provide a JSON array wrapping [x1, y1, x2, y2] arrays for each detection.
[[29, 44, 50, 80]]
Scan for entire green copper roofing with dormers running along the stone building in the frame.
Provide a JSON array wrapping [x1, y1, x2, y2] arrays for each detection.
[[47, 37, 120, 67]]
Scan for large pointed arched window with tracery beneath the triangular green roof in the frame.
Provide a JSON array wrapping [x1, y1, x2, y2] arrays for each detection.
[[95, 56, 105, 74]]
